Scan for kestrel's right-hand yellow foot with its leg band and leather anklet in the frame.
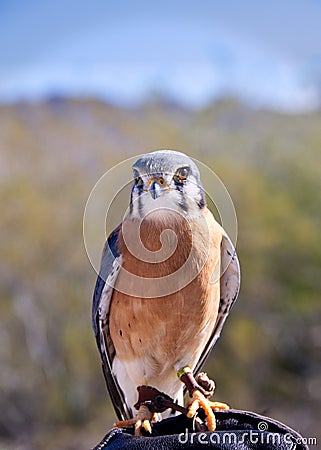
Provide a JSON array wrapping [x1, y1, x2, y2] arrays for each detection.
[[177, 367, 229, 431]]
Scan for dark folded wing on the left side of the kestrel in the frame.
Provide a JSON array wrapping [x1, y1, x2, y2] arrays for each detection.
[[92, 227, 132, 420]]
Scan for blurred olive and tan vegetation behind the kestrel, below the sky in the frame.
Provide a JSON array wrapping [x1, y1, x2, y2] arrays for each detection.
[[0, 97, 321, 450]]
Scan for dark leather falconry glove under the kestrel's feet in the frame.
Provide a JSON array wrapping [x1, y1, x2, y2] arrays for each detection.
[[94, 409, 308, 450]]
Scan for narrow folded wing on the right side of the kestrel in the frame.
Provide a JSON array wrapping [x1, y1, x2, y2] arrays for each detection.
[[194, 232, 241, 373]]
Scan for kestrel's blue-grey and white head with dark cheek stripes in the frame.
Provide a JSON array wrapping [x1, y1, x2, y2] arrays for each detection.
[[130, 150, 206, 218]]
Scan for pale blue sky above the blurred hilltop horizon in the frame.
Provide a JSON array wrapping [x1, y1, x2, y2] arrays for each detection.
[[0, 0, 321, 111]]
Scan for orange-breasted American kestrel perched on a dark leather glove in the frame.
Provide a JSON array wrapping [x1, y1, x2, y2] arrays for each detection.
[[92, 150, 240, 430]]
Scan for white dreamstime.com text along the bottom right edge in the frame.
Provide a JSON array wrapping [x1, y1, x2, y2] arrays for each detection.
[[178, 421, 317, 450]]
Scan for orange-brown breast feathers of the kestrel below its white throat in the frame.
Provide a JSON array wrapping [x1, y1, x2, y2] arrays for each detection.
[[109, 208, 222, 370]]
